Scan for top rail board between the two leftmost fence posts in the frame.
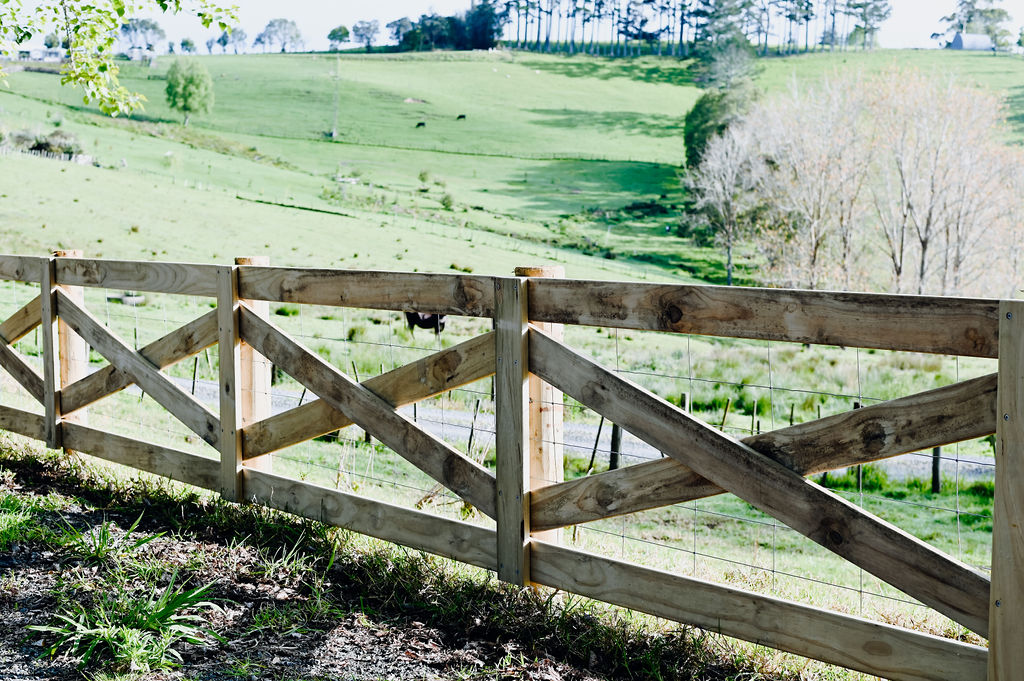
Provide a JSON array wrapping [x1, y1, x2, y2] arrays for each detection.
[[56, 258, 217, 297]]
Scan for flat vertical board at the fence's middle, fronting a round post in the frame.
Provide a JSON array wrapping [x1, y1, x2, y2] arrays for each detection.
[[495, 278, 529, 586]]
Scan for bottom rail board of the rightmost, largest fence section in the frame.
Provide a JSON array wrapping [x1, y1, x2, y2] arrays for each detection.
[[531, 542, 987, 681]]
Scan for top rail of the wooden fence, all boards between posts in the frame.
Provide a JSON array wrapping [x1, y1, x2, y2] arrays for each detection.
[[0, 255, 999, 357]]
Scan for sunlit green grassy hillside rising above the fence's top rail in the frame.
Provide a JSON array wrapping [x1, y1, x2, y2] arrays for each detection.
[[0, 51, 1024, 283]]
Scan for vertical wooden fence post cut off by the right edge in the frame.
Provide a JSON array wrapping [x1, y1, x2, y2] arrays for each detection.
[[988, 300, 1024, 681]]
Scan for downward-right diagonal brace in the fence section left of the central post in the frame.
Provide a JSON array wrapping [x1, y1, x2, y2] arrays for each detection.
[[240, 305, 495, 518]]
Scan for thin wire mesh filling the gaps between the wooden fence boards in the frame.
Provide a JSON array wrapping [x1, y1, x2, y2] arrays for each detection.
[[2, 256, 1007, 679]]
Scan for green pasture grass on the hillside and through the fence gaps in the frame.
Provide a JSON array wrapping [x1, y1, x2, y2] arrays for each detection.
[[0, 46, 1024, 675]]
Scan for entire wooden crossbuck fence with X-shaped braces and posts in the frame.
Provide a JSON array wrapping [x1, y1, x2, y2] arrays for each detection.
[[0, 252, 1024, 681]]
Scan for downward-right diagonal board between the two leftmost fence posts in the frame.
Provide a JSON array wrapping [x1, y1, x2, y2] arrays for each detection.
[[57, 290, 220, 449]]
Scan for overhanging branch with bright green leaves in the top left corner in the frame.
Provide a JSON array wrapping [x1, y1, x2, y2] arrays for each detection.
[[0, 0, 237, 116]]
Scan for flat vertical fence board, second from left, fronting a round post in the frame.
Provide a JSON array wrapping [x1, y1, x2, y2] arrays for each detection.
[[217, 266, 243, 502]]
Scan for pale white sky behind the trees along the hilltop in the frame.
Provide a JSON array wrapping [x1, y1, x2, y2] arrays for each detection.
[[18, 0, 1024, 51]]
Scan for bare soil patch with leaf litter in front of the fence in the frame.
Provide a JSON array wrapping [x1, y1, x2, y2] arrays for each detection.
[[0, 539, 599, 681]]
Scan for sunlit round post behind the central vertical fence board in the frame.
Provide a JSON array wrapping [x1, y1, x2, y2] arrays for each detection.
[[515, 265, 565, 544]]
